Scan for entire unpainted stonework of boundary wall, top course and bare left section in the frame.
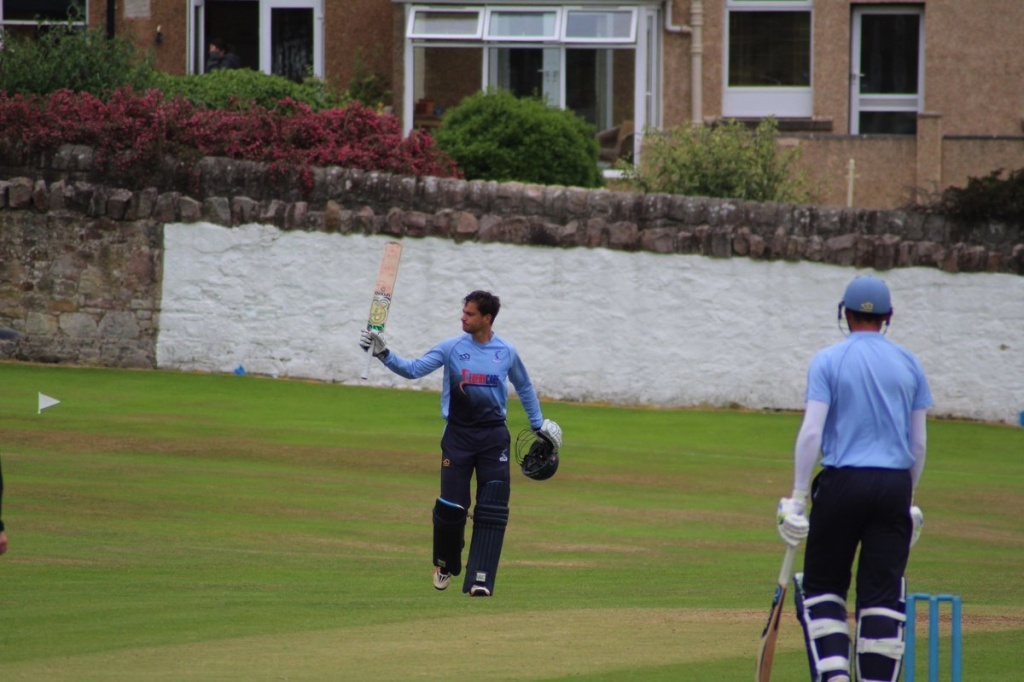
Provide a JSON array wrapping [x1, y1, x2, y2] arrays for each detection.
[[0, 146, 1024, 367]]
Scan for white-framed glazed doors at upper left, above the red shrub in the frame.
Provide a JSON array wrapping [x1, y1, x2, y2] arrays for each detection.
[[188, 0, 325, 81]]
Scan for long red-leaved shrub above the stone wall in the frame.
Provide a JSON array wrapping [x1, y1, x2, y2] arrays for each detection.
[[0, 89, 460, 191]]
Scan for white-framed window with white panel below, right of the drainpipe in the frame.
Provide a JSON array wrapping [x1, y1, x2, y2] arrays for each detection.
[[722, 0, 813, 118]]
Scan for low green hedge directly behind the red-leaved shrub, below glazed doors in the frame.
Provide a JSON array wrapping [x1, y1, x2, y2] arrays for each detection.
[[148, 69, 349, 112]]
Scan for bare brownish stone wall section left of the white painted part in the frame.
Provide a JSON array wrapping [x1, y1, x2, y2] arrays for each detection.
[[0, 209, 163, 369]]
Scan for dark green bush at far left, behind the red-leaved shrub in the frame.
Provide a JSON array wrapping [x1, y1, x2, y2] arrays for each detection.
[[0, 22, 154, 97]]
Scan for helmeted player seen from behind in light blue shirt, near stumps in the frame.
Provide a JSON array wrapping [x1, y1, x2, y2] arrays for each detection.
[[776, 276, 932, 682]]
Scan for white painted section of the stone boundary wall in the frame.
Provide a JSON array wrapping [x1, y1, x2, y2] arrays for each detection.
[[157, 223, 1024, 423]]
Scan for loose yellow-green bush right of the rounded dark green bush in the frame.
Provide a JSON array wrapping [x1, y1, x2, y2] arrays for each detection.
[[622, 118, 810, 203]]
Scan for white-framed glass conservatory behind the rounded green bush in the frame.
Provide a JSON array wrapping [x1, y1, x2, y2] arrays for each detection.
[[399, 0, 662, 165]]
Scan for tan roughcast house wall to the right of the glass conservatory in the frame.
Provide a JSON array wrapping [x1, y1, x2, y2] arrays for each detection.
[[664, 0, 1024, 208]]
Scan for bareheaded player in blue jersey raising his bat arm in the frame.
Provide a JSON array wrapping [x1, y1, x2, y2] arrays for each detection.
[[359, 291, 561, 597]]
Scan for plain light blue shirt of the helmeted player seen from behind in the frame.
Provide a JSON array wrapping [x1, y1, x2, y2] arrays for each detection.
[[806, 332, 932, 469]]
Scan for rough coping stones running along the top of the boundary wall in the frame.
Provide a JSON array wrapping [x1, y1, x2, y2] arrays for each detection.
[[0, 145, 1024, 274]]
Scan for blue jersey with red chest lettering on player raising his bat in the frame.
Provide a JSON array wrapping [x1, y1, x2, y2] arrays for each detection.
[[383, 334, 544, 429]]
